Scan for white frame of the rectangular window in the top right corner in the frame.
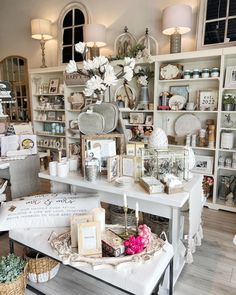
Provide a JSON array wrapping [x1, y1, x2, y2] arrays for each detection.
[[196, 0, 236, 50]]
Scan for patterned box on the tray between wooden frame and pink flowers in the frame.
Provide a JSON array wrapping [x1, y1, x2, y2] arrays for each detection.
[[102, 229, 125, 257]]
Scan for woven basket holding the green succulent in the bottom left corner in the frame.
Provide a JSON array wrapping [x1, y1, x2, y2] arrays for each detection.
[[0, 264, 27, 295]]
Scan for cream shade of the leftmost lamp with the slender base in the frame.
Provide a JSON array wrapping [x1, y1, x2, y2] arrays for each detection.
[[31, 19, 52, 40]]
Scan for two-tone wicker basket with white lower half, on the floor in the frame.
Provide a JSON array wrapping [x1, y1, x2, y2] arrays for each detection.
[[24, 249, 60, 283]]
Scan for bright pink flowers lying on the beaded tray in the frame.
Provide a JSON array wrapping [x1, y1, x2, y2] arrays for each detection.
[[124, 224, 152, 255]]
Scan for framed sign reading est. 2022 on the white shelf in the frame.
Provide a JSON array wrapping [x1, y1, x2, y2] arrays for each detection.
[[198, 90, 218, 111]]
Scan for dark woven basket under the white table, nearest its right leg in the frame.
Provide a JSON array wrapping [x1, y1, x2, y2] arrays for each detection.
[[143, 213, 169, 236]]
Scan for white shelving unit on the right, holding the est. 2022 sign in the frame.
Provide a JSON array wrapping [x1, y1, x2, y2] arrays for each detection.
[[154, 47, 236, 212]]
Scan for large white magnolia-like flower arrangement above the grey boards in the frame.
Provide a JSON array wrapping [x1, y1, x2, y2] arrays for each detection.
[[66, 42, 135, 96]]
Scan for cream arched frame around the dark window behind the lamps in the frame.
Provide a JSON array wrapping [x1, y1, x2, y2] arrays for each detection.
[[58, 2, 91, 65]]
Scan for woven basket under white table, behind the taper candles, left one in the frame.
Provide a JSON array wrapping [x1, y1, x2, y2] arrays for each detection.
[[109, 205, 136, 226]]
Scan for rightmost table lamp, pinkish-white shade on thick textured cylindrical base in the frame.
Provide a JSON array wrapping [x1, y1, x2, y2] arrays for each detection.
[[162, 4, 192, 53]]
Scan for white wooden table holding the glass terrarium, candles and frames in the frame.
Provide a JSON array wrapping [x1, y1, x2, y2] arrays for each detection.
[[39, 172, 202, 284]]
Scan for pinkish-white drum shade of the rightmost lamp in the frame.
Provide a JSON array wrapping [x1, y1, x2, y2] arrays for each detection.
[[162, 4, 192, 35]]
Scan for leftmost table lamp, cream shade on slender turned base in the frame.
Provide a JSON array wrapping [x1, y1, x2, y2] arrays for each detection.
[[31, 19, 52, 68]]
